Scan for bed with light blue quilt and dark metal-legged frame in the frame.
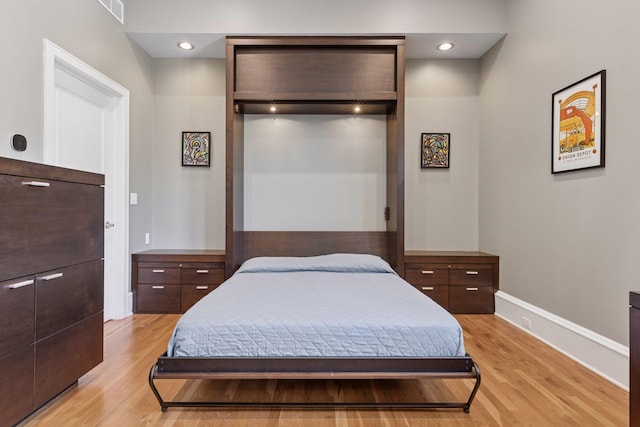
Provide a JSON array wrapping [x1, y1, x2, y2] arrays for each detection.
[[149, 254, 480, 412]]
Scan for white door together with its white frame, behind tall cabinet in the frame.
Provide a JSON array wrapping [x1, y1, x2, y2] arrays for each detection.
[[44, 42, 131, 320]]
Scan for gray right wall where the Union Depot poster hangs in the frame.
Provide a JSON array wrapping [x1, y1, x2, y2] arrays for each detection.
[[479, 0, 640, 343]]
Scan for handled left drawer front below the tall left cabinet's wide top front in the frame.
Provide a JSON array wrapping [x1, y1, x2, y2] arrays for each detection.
[[0, 276, 35, 359]]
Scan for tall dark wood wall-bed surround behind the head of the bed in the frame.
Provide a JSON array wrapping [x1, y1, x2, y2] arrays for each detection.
[[225, 36, 405, 277]]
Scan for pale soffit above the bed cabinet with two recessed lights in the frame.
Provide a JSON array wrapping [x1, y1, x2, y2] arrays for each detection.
[[125, 0, 508, 59]]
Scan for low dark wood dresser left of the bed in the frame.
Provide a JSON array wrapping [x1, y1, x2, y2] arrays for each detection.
[[131, 249, 225, 313]]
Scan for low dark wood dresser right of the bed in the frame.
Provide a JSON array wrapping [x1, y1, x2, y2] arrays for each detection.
[[405, 251, 500, 314]]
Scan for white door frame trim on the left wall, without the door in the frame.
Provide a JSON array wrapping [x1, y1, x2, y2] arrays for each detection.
[[43, 39, 132, 320]]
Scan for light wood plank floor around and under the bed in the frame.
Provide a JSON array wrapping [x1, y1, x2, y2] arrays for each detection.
[[23, 315, 629, 427]]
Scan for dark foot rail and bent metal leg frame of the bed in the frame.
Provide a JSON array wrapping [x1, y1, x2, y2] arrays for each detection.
[[149, 353, 480, 413]]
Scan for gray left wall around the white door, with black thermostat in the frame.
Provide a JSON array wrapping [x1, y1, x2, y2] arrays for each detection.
[[0, 0, 152, 254]]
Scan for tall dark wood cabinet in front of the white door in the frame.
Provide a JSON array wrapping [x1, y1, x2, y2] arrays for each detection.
[[0, 158, 104, 426]]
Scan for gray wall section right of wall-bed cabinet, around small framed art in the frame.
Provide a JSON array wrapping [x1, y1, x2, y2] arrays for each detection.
[[404, 59, 480, 251]]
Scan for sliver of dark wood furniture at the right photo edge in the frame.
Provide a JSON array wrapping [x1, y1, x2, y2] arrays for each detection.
[[629, 292, 640, 427]]
